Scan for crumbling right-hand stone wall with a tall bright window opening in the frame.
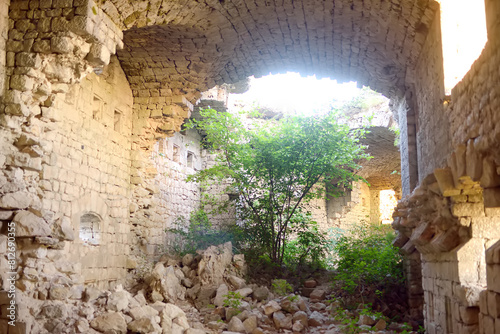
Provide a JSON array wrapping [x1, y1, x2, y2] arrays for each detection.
[[394, 1, 500, 334]]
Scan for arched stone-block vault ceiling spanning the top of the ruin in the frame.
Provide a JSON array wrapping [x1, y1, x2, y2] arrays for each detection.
[[99, 0, 438, 102]]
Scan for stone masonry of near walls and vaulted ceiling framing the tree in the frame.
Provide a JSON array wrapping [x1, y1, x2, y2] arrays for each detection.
[[0, 0, 500, 334]]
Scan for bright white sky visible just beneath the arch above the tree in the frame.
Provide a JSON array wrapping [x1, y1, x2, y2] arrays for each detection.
[[230, 72, 360, 114]]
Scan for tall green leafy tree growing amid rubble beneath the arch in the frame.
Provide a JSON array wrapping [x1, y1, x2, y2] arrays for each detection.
[[188, 109, 368, 264]]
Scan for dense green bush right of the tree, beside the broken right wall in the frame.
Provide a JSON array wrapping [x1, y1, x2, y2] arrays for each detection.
[[334, 226, 404, 301]]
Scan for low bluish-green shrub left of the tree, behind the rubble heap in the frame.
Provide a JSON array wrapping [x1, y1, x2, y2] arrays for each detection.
[[165, 210, 241, 254]]
